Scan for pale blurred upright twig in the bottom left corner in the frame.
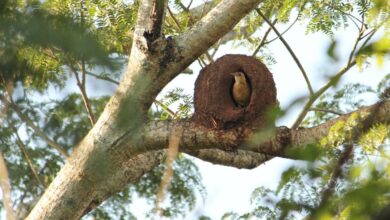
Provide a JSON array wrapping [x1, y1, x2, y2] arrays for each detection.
[[0, 151, 15, 220]]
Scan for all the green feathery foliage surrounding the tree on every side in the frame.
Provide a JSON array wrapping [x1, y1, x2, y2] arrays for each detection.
[[0, 0, 390, 219]]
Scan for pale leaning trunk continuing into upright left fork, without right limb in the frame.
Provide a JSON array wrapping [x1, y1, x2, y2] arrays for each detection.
[[27, 0, 170, 217]]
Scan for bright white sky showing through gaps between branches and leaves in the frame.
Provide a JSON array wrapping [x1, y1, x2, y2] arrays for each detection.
[[1, 1, 390, 219]]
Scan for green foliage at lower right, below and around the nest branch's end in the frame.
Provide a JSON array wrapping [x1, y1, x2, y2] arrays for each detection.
[[233, 76, 390, 219]]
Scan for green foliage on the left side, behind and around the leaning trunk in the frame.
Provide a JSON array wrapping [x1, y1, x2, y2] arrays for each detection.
[[0, 0, 205, 219]]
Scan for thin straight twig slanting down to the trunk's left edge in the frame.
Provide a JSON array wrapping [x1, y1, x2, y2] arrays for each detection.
[[7, 100, 69, 159]]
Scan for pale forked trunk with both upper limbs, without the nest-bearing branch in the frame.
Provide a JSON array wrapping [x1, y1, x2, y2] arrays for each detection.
[[27, 0, 261, 220]]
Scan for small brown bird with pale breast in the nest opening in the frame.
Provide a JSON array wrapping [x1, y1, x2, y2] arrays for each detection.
[[232, 72, 251, 108]]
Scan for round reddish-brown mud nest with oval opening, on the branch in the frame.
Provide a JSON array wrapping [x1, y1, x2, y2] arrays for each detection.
[[193, 55, 277, 129]]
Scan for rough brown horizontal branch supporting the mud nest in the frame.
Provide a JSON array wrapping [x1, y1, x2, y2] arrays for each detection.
[[142, 100, 390, 158]]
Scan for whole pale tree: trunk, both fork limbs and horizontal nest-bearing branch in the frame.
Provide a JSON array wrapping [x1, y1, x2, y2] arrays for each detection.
[[27, 0, 390, 217]]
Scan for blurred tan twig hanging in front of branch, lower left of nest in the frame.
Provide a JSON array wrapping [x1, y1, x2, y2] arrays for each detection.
[[155, 128, 183, 217]]
